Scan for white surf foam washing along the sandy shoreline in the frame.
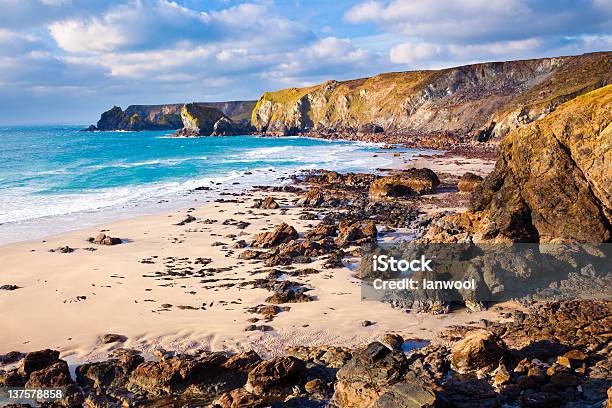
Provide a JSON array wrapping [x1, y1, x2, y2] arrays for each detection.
[[0, 139, 391, 243]]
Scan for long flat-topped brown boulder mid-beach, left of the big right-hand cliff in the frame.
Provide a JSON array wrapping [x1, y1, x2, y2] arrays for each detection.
[[370, 169, 440, 199]]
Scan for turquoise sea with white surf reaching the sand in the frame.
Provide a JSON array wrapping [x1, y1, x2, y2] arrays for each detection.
[[0, 125, 430, 245]]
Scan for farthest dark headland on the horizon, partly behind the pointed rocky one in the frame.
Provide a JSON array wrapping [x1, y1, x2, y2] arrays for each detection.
[[87, 101, 255, 131]]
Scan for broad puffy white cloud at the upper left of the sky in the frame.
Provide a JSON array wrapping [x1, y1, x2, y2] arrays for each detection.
[[49, 0, 314, 53]]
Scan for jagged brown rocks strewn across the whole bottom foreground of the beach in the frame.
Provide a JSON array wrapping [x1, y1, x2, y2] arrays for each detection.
[[0, 300, 612, 408]]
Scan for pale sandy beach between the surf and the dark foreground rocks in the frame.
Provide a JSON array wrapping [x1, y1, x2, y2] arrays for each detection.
[[0, 152, 500, 362]]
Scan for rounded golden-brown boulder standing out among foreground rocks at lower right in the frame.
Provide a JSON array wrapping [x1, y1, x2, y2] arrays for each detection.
[[451, 330, 506, 375]]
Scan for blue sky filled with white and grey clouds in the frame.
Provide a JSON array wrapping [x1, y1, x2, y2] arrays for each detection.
[[0, 0, 612, 125]]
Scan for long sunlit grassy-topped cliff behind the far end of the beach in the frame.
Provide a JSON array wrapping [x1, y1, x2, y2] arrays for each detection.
[[251, 52, 612, 139]]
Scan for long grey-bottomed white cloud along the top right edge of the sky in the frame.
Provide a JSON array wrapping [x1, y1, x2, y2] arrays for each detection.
[[344, 0, 612, 43]]
